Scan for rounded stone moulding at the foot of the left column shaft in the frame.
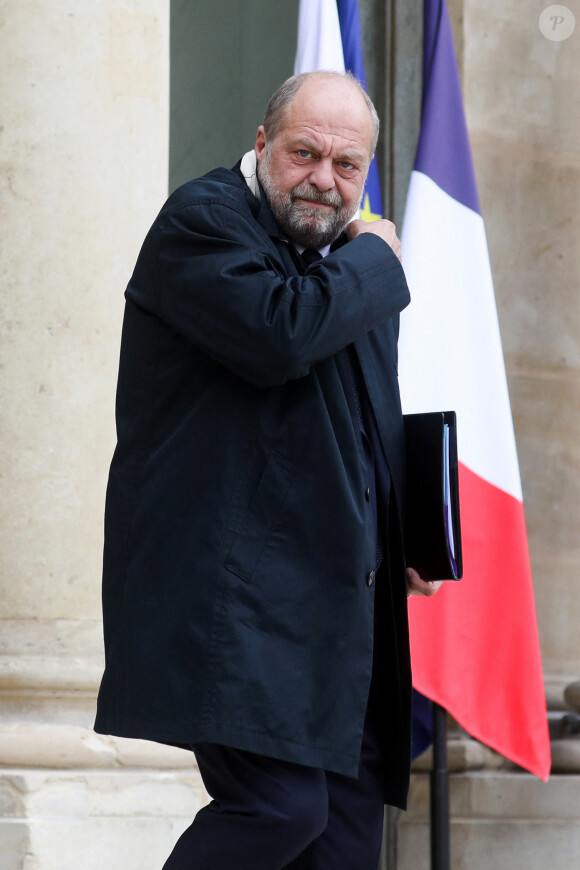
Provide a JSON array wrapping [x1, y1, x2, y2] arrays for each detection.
[[0, 619, 192, 769]]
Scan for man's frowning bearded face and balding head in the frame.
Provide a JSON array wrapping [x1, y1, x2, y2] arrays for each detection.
[[256, 78, 372, 248]]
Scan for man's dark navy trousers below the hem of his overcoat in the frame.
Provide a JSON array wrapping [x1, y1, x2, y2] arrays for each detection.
[[163, 660, 384, 870]]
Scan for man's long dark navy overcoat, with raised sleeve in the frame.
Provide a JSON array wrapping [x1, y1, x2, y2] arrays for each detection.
[[95, 169, 409, 803]]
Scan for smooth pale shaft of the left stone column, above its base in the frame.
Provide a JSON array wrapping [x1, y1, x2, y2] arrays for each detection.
[[0, 0, 169, 619]]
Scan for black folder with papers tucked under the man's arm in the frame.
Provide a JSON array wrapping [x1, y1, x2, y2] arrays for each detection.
[[403, 411, 463, 580]]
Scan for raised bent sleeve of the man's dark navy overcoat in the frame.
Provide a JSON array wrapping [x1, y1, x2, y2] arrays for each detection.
[[127, 202, 410, 387]]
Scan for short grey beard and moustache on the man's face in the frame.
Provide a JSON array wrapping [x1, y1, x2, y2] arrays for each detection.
[[258, 151, 362, 250]]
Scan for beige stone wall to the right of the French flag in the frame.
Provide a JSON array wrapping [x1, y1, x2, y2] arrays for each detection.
[[462, 0, 580, 692]]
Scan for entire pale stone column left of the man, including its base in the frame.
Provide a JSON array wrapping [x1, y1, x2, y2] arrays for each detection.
[[0, 0, 203, 870]]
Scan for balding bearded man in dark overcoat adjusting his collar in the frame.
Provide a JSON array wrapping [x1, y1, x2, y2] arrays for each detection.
[[95, 73, 435, 870]]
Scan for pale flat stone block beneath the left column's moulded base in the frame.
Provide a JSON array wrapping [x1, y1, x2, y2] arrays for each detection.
[[0, 768, 207, 870]]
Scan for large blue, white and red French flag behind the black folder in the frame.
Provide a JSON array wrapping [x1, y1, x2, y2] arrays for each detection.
[[399, 0, 550, 780]]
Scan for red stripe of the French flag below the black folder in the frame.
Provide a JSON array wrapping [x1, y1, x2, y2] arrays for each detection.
[[410, 464, 550, 780]]
